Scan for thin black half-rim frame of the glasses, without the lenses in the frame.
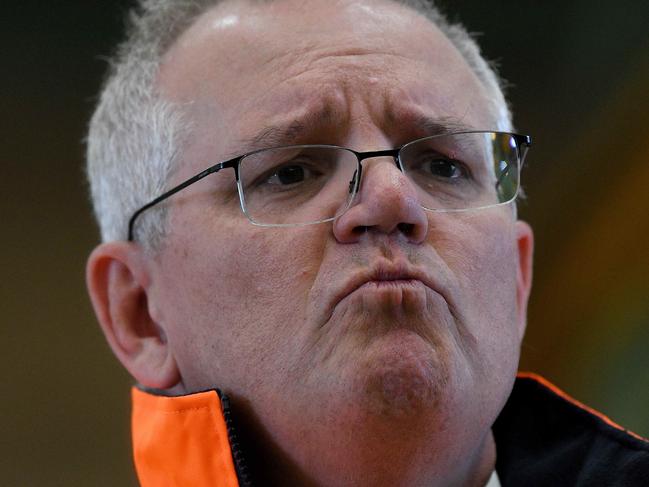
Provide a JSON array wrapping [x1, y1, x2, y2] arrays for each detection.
[[128, 130, 532, 242]]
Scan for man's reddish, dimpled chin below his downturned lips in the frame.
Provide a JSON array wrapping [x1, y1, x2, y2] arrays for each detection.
[[314, 288, 467, 428]]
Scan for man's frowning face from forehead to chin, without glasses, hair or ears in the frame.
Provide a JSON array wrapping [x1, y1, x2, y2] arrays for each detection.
[[149, 0, 527, 478]]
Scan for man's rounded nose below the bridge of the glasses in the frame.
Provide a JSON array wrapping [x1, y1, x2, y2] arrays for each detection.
[[333, 157, 428, 243]]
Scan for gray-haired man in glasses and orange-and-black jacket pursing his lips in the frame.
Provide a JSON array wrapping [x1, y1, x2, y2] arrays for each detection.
[[87, 0, 649, 486]]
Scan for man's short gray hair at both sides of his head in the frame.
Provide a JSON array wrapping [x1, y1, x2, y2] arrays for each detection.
[[87, 0, 512, 249]]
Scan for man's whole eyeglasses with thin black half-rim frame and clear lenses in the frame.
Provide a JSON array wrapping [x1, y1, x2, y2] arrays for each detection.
[[128, 131, 532, 241]]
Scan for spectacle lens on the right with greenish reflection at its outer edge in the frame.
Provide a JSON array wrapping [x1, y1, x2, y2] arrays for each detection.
[[399, 132, 520, 210]]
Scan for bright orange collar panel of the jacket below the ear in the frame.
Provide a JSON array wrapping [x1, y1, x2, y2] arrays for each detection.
[[131, 387, 239, 487]]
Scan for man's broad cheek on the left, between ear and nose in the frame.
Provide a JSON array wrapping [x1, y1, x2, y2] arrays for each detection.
[[154, 221, 326, 390]]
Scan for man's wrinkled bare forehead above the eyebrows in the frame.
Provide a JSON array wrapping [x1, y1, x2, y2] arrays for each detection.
[[159, 0, 494, 155]]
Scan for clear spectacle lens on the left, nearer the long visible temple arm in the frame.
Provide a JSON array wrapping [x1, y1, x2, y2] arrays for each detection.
[[239, 145, 357, 225]]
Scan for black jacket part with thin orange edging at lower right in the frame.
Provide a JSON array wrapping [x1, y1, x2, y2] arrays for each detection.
[[493, 374, 649, 487]]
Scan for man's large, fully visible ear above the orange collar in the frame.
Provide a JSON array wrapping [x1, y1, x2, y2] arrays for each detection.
[[86, 242, 180, 389]]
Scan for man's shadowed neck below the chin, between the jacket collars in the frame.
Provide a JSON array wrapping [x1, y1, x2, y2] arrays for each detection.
[[233, 402, 496, 487]]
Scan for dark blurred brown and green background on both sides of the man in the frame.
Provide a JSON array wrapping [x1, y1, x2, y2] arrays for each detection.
[[0, 0, 649, 486]]
